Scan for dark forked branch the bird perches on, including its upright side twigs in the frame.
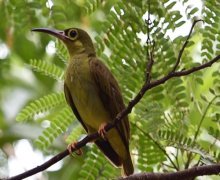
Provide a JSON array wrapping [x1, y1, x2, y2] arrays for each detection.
[[8, 17, 220, 180]]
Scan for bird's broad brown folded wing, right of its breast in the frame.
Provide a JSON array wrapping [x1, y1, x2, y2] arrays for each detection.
[[89, 57, 130, 149]]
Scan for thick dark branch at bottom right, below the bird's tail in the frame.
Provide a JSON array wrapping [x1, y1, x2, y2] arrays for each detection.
[[120, 164, 220, 180]]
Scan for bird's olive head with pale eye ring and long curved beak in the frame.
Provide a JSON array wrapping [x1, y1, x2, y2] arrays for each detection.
[[31, 28, 95, 57]]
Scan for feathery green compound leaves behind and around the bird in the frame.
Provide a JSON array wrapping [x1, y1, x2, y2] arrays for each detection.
[[0, 0, 220, 179]]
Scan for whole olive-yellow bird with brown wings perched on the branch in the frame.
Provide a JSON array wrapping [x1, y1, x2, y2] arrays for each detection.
[[32, 28, 134, 176]]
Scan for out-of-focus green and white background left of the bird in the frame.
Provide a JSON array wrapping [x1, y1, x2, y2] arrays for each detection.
[[0, 0, 111, 179]]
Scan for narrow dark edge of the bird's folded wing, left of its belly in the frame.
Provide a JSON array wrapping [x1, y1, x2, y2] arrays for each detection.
[[64, 83, 88, 132]]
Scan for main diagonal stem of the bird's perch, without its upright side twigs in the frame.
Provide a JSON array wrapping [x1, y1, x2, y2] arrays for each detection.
[[6, 55, 220, 180]]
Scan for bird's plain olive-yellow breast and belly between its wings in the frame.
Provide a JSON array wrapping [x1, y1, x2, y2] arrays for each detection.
[[65, 59, 109, 130]]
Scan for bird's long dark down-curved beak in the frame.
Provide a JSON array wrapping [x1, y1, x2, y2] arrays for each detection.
[[31, 28, 69, 41]]
